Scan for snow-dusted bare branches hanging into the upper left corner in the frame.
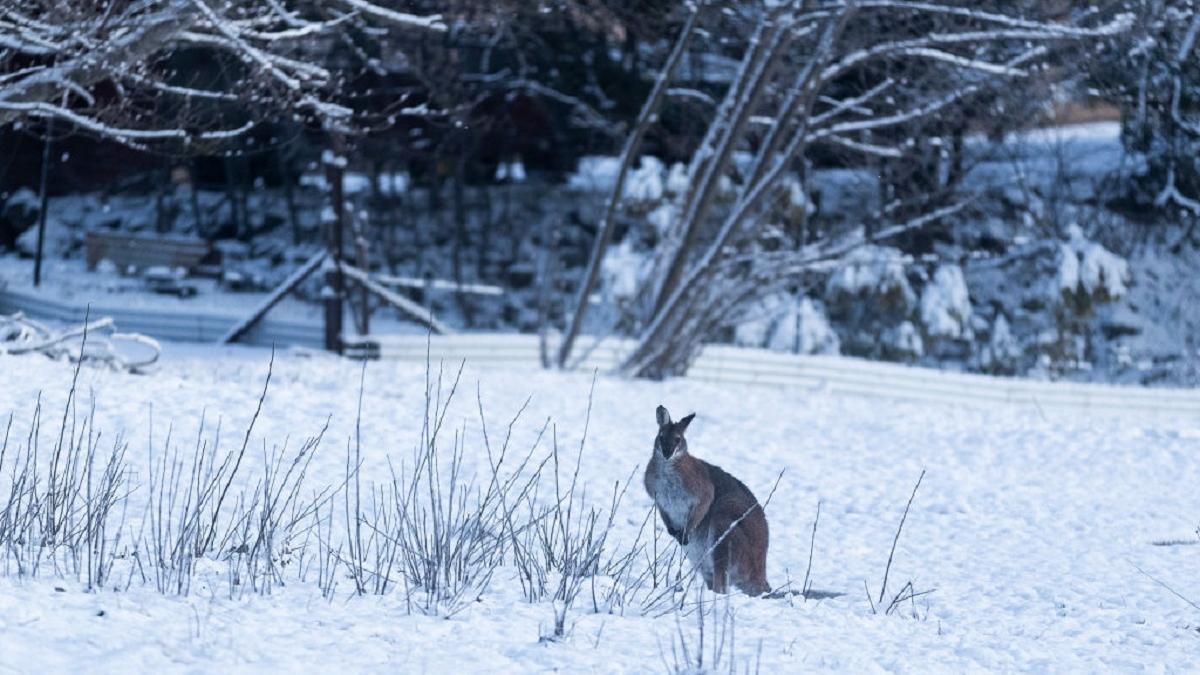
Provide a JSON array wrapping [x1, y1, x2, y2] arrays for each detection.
[[0, 0, 445, 148]]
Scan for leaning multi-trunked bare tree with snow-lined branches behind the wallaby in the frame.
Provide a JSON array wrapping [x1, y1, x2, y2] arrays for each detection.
[[552, 0, 1129, 377]]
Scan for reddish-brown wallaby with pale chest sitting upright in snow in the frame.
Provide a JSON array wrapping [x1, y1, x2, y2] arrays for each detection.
[[644, 406, 770, 596]]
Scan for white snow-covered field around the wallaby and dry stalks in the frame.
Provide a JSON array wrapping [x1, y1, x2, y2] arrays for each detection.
[[0, 345, 1200, 673]]
